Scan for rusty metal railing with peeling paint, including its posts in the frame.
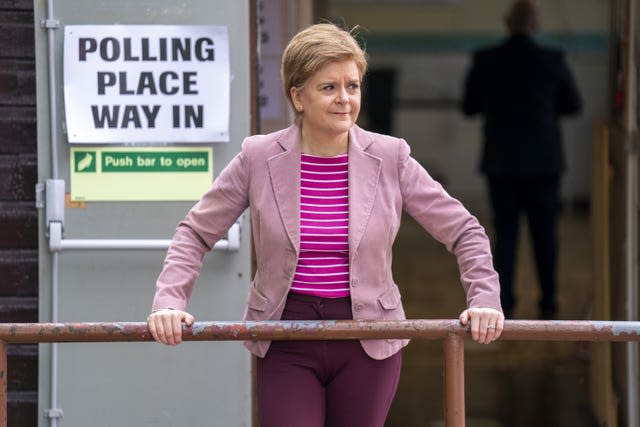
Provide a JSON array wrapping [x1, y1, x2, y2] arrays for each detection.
[[0, 320, 640, 427]]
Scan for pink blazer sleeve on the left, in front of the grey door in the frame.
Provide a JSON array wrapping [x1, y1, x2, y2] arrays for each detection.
[[152, 141, 249, 311]]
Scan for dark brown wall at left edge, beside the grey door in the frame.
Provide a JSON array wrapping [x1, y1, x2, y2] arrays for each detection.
[[0, 0, 38, 427]]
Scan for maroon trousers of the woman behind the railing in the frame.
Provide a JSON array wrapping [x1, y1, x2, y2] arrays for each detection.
[[257, 294, 402, 427]]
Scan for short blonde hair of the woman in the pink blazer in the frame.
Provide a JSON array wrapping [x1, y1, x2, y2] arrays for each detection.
[[280, 23, 367, 114]]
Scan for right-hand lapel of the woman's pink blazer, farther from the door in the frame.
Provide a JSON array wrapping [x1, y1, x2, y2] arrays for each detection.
[[349, 125, 381, 261]]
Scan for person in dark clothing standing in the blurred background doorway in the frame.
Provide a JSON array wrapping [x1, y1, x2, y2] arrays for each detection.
[[462, 0, 582, 318]]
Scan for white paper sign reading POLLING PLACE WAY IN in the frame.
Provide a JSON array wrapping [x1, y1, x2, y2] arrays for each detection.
[[64, 25, 230, 144]]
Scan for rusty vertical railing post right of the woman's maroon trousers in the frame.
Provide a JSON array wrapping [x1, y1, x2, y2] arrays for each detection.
[[444, 334, 465, 427]]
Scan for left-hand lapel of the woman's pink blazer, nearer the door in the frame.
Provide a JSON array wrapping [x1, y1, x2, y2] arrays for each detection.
[[265, 126, 300, 254]]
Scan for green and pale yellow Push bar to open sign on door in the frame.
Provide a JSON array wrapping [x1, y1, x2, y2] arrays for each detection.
[[70, 147, 213, 201]]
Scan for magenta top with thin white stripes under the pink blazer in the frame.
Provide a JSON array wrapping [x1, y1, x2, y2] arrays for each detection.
[[291, 154, 349, 298]]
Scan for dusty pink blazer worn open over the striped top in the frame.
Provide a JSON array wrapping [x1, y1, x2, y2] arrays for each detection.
[[153, 125, 501, 359]]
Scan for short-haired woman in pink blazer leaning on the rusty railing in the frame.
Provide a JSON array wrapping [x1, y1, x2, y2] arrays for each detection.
[[148, 24, 504, 427]]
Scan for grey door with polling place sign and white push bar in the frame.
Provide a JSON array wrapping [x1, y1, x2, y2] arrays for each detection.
[[34, 0, 253, 427]]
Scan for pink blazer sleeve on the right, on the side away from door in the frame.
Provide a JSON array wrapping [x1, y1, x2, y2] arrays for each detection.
[[399, 140, 502, 311]]
